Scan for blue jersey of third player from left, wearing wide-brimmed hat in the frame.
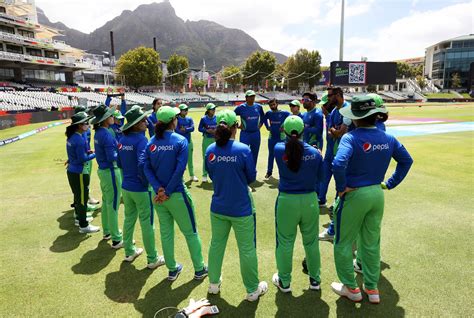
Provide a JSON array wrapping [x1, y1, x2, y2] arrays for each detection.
[[118, 132, 148, 192]]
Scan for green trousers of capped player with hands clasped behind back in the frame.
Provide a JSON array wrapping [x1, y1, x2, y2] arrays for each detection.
[[155, 190, 204, 271]]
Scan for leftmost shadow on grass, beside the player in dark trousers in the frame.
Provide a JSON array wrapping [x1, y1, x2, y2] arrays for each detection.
[[49, 210, 91, 253]]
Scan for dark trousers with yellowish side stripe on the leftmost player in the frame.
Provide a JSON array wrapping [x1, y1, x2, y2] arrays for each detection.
[[67, 171, 90, 227]]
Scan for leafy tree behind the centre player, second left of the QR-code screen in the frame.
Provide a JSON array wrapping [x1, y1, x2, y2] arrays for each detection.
[[243, 51, 277, 87]]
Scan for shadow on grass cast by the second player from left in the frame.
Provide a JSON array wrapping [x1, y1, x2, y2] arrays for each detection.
[[71, 240, 117, 275]]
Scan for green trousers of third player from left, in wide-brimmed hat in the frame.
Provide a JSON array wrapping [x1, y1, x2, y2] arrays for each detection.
[[122, 189, 157, 263]]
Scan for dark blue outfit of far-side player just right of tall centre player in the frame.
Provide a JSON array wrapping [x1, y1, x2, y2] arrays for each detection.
[[263, 110, 290, 174]]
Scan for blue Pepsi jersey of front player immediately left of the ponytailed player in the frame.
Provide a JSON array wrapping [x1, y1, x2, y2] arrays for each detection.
[[205, 140, 257, 217]]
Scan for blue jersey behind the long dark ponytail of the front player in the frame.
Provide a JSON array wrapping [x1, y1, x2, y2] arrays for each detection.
[[275, 142, 323, 194]]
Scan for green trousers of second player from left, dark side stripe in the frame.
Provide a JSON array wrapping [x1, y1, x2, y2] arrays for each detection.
[[97, 168, 122, 242]]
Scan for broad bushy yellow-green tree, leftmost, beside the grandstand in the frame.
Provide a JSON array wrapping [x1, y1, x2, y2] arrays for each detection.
[[116, 46, 163, 89]]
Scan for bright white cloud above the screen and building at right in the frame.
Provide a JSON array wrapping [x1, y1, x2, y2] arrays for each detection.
[[344, 2, 474, 61]]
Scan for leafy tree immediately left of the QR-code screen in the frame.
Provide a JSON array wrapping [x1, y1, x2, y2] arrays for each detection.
[[286, 49, 321, 89]]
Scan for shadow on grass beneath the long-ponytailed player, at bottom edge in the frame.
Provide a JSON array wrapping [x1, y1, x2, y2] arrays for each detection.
[[275, 290, 329, 317]]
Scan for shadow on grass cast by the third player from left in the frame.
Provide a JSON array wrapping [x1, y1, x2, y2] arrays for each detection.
[[104, 262, 153, 303]]
